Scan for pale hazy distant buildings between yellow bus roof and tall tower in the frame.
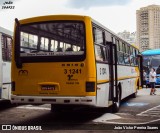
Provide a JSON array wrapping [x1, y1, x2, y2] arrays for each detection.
[[118, 30, 136, 45]]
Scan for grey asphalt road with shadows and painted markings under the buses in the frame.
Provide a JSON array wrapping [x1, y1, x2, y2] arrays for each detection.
[[0, 88, 160, 133]]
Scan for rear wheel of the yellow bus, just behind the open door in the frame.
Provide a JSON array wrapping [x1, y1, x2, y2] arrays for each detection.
[[112, 89, 121, 113]]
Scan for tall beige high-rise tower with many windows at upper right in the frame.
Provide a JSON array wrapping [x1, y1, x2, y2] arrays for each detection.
[[136, 5, 160, 51]]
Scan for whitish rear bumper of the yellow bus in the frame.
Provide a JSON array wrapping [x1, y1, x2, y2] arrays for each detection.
[[11, 95, 96, 106]]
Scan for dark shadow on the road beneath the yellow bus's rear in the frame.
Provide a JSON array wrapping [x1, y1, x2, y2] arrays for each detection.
[[8, 105, 111, 129]]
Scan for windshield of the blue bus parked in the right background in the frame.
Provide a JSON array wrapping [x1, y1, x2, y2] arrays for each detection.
[[143, 55, 160, 74]]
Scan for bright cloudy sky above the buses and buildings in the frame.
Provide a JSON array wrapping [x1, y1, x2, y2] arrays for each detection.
[[0, 0, 160, 33]]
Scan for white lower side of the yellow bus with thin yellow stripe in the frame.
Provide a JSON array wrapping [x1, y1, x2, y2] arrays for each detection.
[[97, 63, 139, 107]]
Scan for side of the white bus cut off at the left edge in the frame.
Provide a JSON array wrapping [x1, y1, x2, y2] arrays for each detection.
[[0, 27, 13, 100]]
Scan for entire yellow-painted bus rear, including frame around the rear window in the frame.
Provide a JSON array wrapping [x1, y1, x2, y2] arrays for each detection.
[[12, 15, 96, 104]]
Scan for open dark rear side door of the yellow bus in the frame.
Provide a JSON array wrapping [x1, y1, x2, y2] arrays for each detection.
[[106, 42, 119, 104]]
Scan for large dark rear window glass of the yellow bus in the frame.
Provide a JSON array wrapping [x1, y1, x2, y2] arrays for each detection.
[[20, 21, 85, 58]]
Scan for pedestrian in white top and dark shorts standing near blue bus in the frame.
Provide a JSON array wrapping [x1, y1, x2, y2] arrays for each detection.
[[149, 68, 156, 95]]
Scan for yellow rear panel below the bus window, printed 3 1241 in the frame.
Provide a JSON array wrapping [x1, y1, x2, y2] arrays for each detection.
[[14, 62, 91, 96]]
